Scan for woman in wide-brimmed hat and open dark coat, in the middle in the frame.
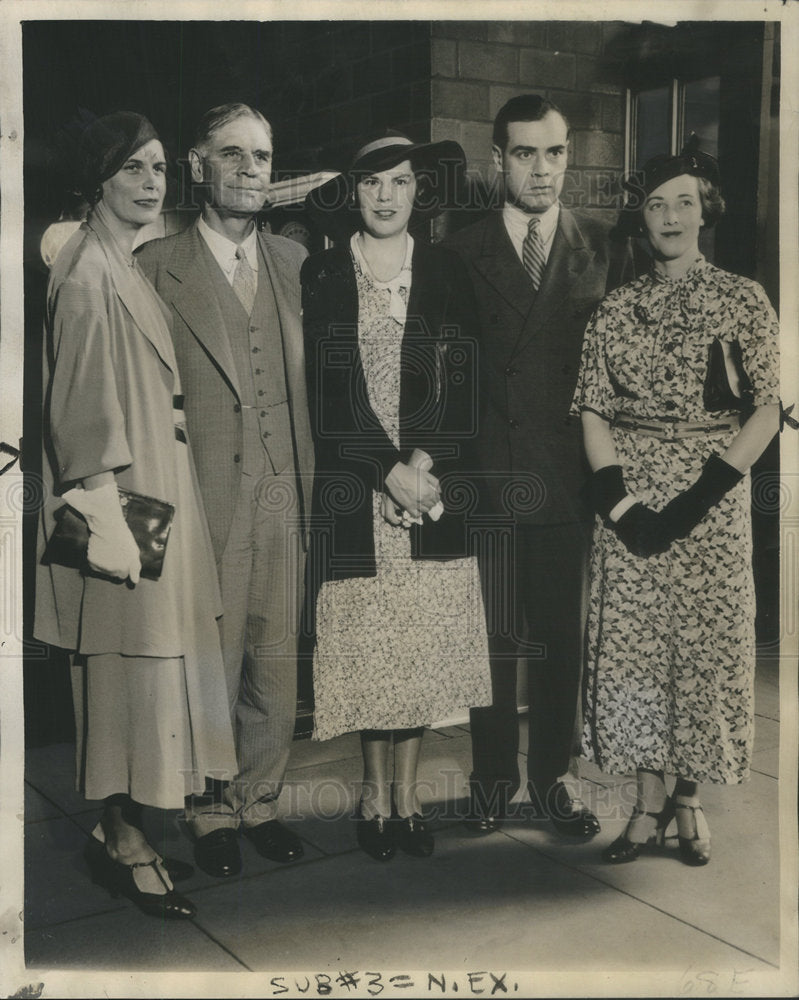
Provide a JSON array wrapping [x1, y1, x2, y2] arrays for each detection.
[[302, 133, 491, 860]]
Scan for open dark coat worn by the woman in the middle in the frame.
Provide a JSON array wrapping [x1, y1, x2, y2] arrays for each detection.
[[301, 241, 479, 589]]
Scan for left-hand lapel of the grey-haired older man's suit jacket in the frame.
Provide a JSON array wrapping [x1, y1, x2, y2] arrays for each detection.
[[166, 223, 241, 398]]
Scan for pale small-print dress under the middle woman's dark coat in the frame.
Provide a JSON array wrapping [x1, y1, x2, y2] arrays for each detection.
[[313, 238, 491, 740]]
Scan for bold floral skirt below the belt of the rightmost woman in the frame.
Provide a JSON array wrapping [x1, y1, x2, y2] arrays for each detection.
[[583, 428, 755, 783]]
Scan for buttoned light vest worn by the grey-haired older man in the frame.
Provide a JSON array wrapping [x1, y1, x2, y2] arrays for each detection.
[[205, 243, 294, 476]]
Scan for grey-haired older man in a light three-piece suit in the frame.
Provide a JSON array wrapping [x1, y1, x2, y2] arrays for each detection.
[[139, 104, 313, 877]]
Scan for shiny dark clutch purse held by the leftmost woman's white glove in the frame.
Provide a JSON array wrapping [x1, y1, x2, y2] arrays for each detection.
[[42, 488, 175, 580]]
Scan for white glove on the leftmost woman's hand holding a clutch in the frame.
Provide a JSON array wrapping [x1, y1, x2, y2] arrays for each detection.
[[64, 483, 141, 583]]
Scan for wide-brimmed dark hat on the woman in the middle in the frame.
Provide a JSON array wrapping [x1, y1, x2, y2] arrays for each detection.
[[305, 130, 466, 240]]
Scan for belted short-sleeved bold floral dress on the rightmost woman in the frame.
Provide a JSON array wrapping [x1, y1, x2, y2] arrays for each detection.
[[572, 257, 779, 783]]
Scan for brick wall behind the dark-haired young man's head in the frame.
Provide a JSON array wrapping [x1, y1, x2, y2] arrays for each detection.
[[431, 21, 625, 232]]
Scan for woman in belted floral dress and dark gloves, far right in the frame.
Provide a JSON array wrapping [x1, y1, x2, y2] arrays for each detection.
[[573, 143, 779, 865]]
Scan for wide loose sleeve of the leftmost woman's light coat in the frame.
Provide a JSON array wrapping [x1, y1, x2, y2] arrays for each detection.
[[48, 280, 133, 484]]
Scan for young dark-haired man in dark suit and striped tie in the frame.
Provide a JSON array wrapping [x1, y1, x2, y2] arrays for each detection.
[[450, 95, 624, 837]]
